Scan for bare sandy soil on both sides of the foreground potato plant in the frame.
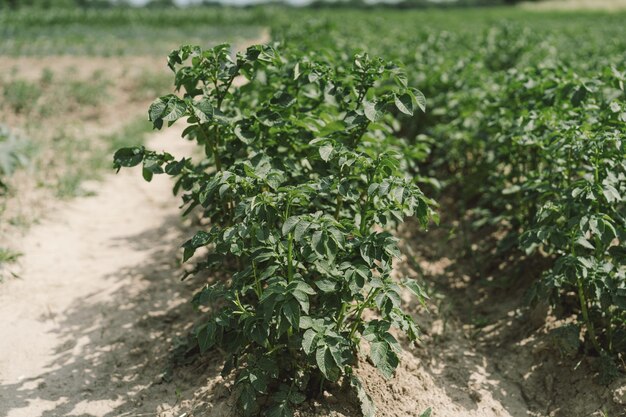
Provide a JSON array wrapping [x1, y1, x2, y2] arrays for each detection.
[[0, 30, 626, 417]]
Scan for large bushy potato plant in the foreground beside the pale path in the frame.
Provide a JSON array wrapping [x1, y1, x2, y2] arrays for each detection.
[[115, 45, 436, 417]]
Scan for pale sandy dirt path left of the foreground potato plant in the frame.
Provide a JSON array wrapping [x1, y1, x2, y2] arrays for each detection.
[[0, 129, 197, 417]]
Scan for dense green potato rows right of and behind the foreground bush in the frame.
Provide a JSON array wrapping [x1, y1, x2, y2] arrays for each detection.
[[274, 16, 626, 369]]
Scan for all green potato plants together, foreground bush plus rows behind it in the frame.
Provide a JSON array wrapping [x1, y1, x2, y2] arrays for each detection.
[[115, 9, 626, 416]]
